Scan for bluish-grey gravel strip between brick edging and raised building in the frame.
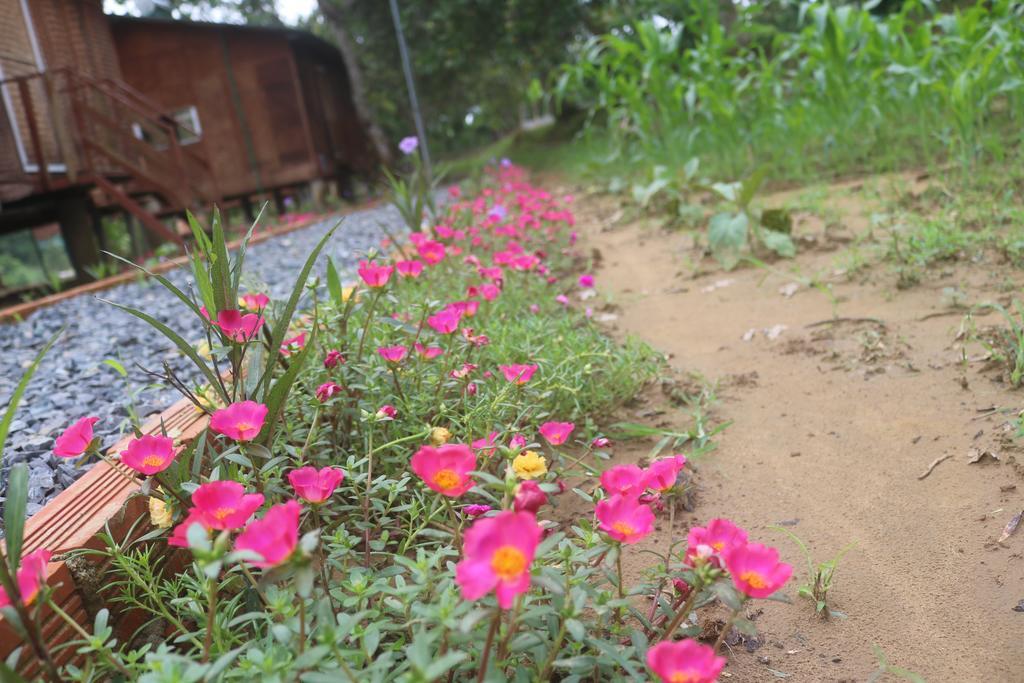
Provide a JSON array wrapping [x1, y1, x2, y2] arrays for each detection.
[[0, 206, 403, 515]]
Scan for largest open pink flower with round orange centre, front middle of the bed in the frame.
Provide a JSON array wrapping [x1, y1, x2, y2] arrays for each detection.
[[455, 510, 542, 609]]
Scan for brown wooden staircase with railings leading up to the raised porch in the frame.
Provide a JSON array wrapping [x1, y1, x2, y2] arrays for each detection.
[[0, 69, 221, 247]]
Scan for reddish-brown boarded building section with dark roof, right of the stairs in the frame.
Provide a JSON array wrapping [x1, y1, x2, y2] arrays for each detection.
[[111, 16, 376, 214]]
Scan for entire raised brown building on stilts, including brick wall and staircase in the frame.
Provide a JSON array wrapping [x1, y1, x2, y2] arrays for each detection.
[[0, 0, 376, 298]]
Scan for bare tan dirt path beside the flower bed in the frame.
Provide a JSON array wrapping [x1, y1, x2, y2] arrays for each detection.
[[578, 179, 1024, 681]]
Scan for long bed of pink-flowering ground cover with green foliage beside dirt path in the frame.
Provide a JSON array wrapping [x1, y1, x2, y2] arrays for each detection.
[[0, 165, 792, 683]]
